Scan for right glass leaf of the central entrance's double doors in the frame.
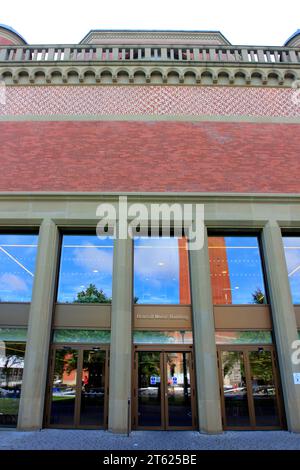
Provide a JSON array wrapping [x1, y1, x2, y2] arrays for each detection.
[[165, 352, 193, 427]]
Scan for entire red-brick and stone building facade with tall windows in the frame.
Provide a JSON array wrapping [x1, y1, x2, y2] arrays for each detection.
[[0, 25, 300, 433]]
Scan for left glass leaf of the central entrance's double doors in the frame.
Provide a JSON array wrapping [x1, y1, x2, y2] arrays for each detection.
[[137, 351, 162, 427]]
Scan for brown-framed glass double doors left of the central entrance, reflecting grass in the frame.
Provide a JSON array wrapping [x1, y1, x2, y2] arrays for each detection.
[[47, 345, 108, 428]]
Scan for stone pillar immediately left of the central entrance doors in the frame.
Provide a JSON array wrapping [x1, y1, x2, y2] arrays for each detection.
[[108, 239, 133, 433]]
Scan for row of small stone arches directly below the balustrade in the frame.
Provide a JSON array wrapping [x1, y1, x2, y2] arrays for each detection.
[[0, 63, 300, 87]]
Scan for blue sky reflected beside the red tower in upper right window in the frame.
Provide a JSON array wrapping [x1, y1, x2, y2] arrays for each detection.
[[212, 236, 265, 304]]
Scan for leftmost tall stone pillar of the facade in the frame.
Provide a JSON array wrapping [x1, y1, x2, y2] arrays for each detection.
[[18, 219, 59, 430]]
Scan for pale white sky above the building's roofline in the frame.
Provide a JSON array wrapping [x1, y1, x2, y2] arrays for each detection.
[[0, 0, 300, 46]]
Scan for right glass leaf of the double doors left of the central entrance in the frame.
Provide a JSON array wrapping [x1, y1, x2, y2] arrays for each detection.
[[80, 348, 106, 426]]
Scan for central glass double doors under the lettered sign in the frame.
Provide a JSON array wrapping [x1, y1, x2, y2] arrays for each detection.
[[133, 351, 195, 429]]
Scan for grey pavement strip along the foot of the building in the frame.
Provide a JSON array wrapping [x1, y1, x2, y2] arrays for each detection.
[[0, 429, 300, 450]]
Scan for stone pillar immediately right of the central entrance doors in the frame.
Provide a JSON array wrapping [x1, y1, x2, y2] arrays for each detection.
[[190, 228, 222, 434]]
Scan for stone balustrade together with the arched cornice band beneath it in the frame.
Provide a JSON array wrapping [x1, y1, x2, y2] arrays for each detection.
[[0, 41, 300, 87]]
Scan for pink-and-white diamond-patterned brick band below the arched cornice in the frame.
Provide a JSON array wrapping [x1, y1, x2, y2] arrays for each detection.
[[0, 86, 300, 117]]
